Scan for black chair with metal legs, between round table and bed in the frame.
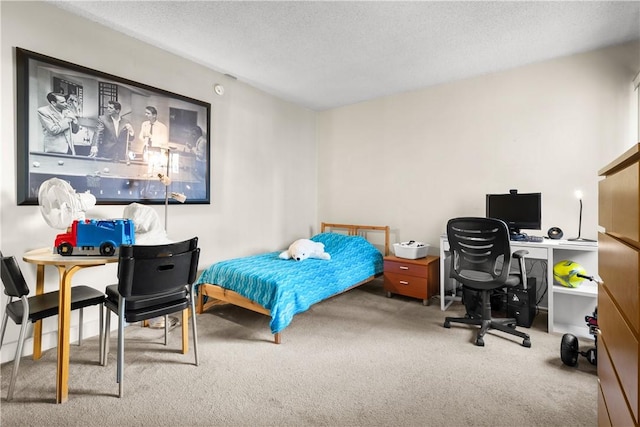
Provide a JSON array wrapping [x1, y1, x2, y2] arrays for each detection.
[[102, 237, 200, 397]]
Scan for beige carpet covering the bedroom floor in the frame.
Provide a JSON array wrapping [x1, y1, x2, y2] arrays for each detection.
[[0, 281, 597, 427]]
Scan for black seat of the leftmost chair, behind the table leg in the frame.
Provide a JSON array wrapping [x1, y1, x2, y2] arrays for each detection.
[[7, 285, 104, 325]]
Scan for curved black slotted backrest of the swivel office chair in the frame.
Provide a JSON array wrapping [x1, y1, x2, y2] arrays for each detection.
[[447, 217, 511, 290]]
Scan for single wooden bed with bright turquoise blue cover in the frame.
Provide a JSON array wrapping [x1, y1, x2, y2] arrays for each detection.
[[196, 223, 389, 344]]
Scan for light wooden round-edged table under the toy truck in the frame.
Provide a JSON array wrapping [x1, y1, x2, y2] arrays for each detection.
[[22, 248, 118, 403]]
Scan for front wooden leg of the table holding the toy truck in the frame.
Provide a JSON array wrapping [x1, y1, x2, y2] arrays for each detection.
[[56, 266, 81, 403]]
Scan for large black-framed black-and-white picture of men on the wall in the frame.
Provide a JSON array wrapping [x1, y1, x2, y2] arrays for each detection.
[[15, 47, 211, 205]]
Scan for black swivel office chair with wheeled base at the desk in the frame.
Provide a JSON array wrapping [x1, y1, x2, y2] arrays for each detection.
[[444, 218, 531, 347]]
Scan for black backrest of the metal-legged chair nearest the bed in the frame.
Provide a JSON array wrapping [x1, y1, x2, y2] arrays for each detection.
[[118, 237, 200, 298]]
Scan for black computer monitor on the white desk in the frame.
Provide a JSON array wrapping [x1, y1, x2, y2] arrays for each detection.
[[486, 190, 542, 235]]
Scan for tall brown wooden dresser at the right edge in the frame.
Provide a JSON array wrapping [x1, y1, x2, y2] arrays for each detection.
[[598, 144, 640, 427]]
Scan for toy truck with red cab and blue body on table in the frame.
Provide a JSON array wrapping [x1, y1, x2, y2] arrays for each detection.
[[55, 219, 135, 256]]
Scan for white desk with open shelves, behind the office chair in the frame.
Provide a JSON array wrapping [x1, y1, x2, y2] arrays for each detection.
[[440, 235, 599, 339]]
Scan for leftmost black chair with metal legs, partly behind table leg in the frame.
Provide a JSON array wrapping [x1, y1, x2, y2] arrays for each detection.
[[0, 253, 105, 400]]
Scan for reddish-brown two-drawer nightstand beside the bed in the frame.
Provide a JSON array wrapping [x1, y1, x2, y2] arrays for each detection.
[[384, 255, 440, 305]]
